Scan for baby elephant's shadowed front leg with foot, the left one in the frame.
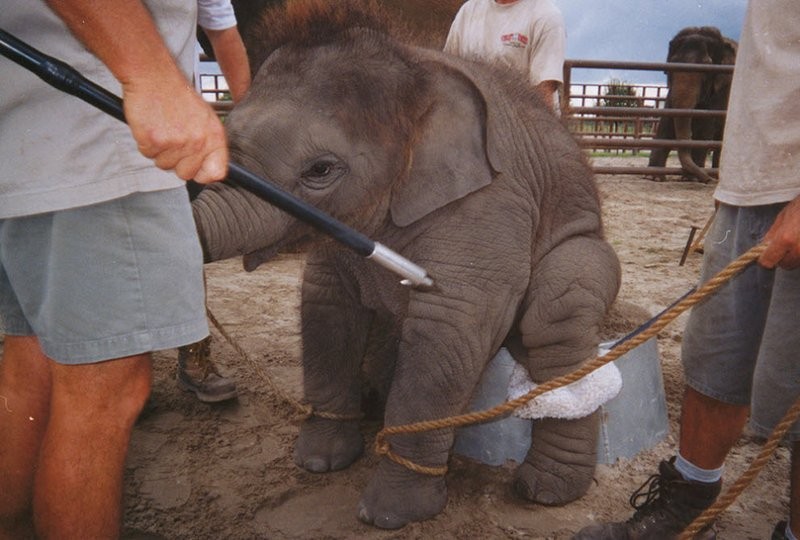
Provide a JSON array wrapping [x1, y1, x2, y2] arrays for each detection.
[[294, 260, 371, 472]]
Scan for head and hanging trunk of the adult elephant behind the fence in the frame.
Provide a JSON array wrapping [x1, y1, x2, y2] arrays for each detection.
[[667, 26, 736, 182]]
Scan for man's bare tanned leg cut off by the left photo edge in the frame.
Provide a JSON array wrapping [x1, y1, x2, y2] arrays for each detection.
[[0, 336, 50, 540]]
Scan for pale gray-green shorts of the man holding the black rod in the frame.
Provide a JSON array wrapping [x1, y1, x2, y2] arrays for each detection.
[[0, 187, 208, 364]]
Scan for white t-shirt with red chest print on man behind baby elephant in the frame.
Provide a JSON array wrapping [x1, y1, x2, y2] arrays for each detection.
[[444, 0, 566, 85]]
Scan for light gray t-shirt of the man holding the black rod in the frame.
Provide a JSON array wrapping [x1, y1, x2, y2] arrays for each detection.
[[0, 0, 197, 218]]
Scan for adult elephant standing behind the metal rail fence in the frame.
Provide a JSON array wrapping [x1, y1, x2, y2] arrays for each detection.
[[649, 26, 737, 182]]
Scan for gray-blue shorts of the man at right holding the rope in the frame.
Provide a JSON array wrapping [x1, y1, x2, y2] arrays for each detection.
[[682, 204, 800, 441]]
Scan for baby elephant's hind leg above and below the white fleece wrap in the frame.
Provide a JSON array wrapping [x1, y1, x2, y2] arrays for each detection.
[[509, 238, 620, 505]]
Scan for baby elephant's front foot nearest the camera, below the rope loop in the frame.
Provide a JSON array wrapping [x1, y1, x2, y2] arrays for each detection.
[[358, 458, 447, 529]]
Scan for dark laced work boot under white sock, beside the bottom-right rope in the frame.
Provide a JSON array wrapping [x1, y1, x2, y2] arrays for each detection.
[[573, 457, 722, 540]]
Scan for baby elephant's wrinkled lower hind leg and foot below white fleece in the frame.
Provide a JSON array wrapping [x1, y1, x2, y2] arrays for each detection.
[[513, 412, 600, 506]]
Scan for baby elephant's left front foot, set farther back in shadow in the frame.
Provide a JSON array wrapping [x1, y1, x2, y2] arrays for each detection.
[[294, 417, 364, 472]]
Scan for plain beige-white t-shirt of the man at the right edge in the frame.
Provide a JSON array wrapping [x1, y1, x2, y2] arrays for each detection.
[[714, 0, 800, 206]]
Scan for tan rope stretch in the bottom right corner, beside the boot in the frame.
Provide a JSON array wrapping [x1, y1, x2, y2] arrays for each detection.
[[680, 397, 800, 540]]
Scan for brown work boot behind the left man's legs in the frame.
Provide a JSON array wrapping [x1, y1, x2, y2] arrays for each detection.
[[178, 336, 237, 403]]
